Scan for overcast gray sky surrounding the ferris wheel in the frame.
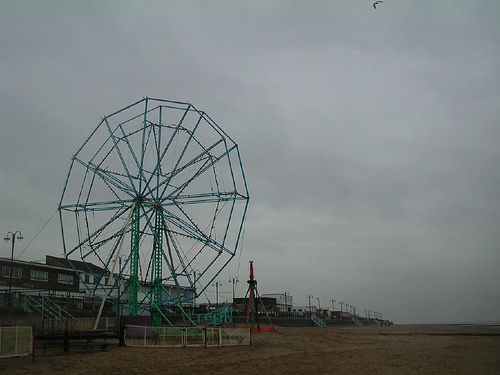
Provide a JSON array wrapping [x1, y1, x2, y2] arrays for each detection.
[[0, 0, 500, 323]]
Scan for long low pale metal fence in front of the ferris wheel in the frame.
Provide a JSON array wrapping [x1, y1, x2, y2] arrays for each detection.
[[125, 325, 251, 347]]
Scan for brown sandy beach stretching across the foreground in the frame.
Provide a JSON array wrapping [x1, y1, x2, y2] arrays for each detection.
[[0, 325, 500, 375]]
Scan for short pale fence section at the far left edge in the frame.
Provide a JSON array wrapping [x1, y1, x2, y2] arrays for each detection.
[[0, 326, 33, 358]]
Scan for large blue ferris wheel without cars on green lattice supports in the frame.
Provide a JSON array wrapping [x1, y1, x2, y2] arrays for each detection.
[[59, 98, 249, 315]]
